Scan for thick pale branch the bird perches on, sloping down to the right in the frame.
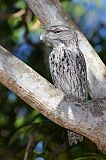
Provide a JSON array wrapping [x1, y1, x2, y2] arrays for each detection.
[[0, 46, 106, 153]]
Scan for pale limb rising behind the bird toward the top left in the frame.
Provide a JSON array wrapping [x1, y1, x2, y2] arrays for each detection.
[[26, 0, 106, 98]]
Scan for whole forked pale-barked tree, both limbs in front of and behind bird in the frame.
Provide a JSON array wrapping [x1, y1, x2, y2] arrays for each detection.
[[0, 0, 106, 153]]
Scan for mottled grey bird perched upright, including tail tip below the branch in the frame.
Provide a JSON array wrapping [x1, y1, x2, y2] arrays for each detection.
[[40, 25, 88, 145]]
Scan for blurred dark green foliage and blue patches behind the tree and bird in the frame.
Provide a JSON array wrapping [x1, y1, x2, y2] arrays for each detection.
[[0, 0, 106, 160]]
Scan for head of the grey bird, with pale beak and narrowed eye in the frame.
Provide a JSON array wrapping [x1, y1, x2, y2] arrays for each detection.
[[40, 25, 76, 47]]
